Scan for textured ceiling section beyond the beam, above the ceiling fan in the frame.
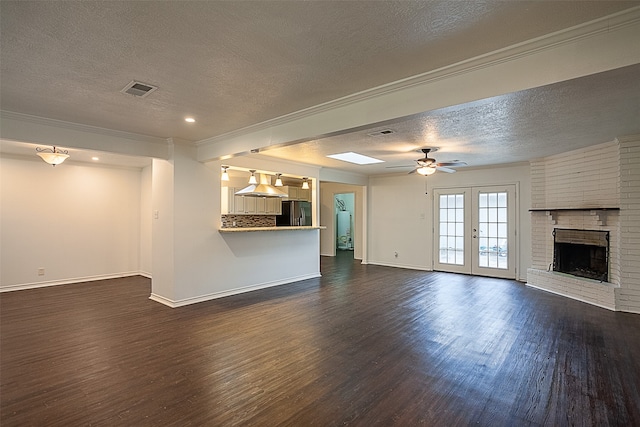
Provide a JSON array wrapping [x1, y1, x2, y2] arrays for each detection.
[[261, 65, 640, 174]]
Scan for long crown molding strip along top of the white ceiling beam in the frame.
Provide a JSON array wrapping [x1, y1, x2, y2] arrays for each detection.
[[195, 6, 640, 147]]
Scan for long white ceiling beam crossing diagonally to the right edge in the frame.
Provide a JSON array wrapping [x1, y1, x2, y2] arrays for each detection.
[[196, 7, 640, 162]]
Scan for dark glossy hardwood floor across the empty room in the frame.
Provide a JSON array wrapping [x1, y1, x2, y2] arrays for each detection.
[[0, 253, 640, 427]]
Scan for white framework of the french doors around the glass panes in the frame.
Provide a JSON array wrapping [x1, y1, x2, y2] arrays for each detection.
[[431, 182, 520, 280]]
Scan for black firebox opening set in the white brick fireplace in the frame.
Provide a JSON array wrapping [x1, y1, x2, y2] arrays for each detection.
[[553, 228, 609, 282]]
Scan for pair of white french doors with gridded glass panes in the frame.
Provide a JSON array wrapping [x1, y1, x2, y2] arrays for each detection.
[[434, 185, 517, 279]]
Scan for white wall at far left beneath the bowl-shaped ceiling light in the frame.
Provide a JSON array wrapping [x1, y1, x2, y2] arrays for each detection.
[[0, 155, 141, 290]]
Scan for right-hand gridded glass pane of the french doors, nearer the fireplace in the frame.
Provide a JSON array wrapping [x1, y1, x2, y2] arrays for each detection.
[[478, 192, 509, 270]]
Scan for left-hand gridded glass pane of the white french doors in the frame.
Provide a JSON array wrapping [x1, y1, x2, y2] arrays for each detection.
[[439, 194, 464, 265]]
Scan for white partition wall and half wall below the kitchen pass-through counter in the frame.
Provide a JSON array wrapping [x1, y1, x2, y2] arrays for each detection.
[[151, 144, 320, 307]]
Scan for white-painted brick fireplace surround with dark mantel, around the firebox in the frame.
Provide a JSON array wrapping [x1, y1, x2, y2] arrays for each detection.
[[527, 135, 640, 314]]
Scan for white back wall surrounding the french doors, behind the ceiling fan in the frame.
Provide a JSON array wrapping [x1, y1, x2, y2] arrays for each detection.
[[367, 164, 531, 280]]
